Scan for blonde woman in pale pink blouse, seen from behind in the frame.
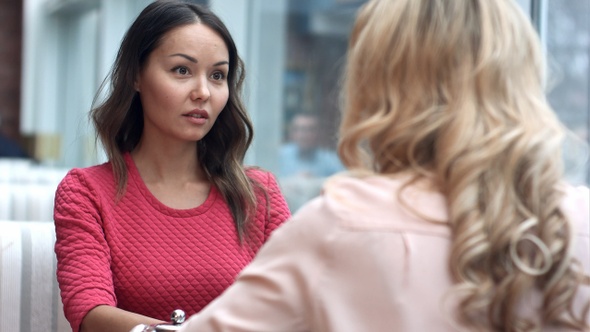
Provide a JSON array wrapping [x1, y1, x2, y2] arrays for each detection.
[[135, 0, 590, 332]]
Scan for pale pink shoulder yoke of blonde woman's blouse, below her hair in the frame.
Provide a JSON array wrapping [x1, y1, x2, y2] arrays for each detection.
[[321, 172, 448, 234]]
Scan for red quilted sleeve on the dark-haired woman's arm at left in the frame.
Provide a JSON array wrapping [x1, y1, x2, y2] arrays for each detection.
[[54, 169, 116, 332]]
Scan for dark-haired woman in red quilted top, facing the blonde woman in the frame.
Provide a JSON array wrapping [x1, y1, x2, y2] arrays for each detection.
[[55, 1, 290, 332]]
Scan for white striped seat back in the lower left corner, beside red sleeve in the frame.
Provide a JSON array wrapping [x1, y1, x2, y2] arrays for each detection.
[[0, 221, 71, 332]]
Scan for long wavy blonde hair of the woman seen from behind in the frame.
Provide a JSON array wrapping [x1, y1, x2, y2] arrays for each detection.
[[338, 0, 590, 331]]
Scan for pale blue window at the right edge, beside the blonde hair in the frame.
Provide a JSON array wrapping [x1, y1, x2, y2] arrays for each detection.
[[535, 1, 590, 184]]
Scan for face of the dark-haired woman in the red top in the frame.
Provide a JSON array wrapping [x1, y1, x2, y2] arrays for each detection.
[[135, 23, 229, 142]]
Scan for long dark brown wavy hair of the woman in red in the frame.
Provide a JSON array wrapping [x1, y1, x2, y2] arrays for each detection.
[[90, 0, 263, 239]]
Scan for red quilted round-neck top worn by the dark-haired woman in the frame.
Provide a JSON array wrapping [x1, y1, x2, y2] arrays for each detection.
[[54, 154, 290, 332]]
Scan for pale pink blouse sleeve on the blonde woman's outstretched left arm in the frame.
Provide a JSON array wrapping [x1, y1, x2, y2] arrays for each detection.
[[180, 197, 329, 332]]
